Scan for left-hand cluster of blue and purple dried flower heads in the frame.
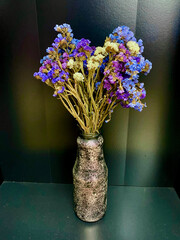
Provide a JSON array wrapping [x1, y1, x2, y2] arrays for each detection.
[[34, 24, 95, 96]]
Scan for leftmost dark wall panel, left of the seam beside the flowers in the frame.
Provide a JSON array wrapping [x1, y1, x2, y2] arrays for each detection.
[[0, 0, 51, 182]]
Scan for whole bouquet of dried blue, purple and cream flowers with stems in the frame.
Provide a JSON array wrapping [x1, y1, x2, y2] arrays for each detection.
[[34, 24, 152, 134]]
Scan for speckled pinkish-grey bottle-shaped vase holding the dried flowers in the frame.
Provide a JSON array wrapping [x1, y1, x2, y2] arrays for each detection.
[[73, 135, 108, 222]]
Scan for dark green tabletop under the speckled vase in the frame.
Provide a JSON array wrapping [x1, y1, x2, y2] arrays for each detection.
[[0, 182, 180, 240]]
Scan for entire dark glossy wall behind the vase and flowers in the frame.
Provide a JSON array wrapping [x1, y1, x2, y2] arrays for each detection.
[[0, 0, 180, 192]]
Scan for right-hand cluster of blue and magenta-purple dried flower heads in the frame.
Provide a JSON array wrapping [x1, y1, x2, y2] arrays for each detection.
[[104, 26, 152, 111]]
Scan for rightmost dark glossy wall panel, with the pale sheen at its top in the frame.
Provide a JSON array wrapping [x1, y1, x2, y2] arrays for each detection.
[[125, 0, 180, 186]]
